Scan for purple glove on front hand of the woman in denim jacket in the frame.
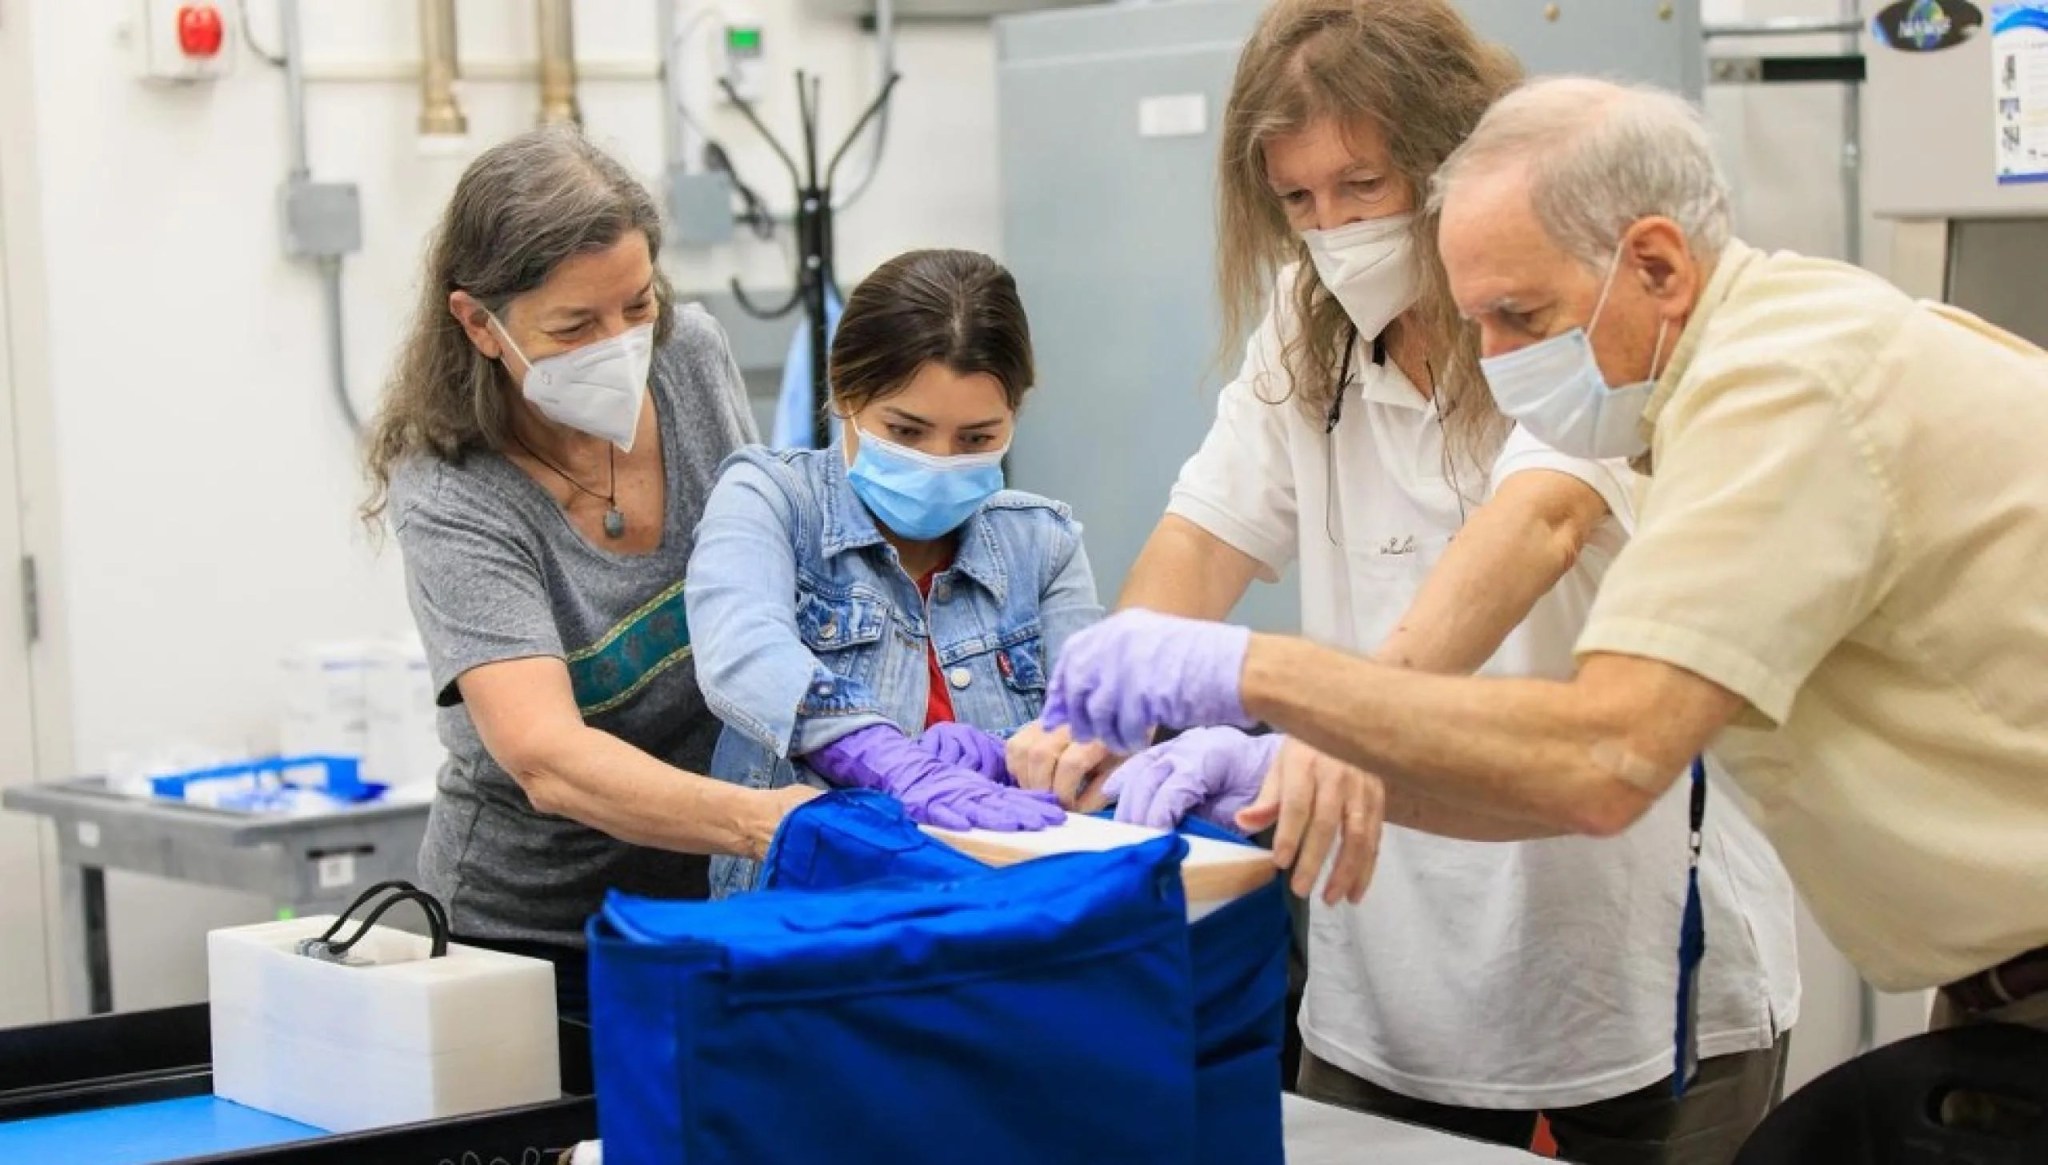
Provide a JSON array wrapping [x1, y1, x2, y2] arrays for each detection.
[[803, 725, 1067, 831]]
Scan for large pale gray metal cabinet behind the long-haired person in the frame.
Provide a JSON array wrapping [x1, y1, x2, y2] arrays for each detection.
[[995, 0, 1704, 631]]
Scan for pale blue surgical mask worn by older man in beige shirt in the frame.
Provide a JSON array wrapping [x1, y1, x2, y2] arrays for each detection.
[[1479, 248, 1669, 459]]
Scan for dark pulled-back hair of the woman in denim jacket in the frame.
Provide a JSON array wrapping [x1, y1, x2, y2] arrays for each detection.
[[829, 250, 1034, 416]]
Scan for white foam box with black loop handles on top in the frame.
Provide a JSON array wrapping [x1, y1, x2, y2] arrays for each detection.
[[207, 905, 561, 1132]]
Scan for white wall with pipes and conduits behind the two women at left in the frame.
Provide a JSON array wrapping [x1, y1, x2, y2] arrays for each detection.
[[16, 0, 997, 1007]]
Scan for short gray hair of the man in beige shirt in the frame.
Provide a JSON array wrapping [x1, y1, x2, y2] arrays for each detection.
[[1430, 78, 1729, 270]]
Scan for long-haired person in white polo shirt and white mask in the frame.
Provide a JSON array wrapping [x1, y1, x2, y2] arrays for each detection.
[[1018, 0, 1798, 1163]]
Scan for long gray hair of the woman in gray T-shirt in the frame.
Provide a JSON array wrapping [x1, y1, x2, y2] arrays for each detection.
[[362, 125, 676, 522]]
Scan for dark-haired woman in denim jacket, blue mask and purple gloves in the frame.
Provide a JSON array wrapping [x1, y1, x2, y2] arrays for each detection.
[[686, 252, 1102, 895]]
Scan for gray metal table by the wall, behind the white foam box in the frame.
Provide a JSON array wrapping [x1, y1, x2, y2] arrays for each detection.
[[0, 776, 428, 1016]]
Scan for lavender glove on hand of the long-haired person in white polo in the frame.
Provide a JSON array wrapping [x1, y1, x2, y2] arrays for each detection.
[[1104, 729, 1286, 829]]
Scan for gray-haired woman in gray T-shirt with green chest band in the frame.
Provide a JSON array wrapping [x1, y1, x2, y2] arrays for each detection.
[[365, 127, 815, 1011]]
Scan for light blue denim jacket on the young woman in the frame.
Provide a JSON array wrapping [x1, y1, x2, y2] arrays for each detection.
[[684, 446, 1102, 895]]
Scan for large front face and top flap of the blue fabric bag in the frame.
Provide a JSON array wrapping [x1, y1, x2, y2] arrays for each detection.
[[588, 794, 1196, 1165]]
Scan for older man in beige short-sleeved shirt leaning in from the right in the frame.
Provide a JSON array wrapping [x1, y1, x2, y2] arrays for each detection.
[[1049, 80, 2048, 1028]]
